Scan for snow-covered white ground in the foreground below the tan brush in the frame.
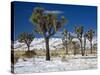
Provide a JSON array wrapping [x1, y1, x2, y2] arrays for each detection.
[[14, 56, 97, 74]]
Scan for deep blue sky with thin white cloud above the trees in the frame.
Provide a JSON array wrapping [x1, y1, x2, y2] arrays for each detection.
[[13, 2, 97, 40]]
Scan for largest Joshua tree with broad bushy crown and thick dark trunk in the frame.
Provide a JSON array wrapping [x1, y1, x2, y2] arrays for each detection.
[[30, 7, 66, 61]]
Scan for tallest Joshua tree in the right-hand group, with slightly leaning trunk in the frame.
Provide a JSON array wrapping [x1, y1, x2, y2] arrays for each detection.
[[75, 26, 84, 56]]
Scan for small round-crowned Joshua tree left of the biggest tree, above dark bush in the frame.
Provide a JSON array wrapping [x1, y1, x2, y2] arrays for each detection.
[[18, 32, 34, 51]]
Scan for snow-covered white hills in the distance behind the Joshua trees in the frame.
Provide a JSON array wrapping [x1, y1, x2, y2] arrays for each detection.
[[14, 38, 97, 51]]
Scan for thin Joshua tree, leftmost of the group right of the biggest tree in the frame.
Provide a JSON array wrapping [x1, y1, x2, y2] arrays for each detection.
[[62, 29, 68, 54]]
